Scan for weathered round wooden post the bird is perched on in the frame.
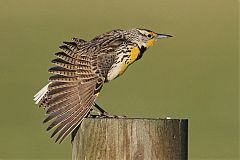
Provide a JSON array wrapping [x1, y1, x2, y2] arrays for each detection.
[[72, 118, 188, 160]]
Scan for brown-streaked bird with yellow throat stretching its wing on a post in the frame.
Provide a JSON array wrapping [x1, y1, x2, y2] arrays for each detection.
[[34, 28, 172, 143]]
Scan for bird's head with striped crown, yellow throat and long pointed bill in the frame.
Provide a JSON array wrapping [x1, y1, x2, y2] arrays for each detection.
[[126, 28, 172, 49]]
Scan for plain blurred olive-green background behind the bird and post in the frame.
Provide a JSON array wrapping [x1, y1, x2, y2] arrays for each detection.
[[0, 0, 239, 160]]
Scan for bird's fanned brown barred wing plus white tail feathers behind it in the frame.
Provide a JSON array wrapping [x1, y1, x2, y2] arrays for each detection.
[[34, 39, 103, 143]]
